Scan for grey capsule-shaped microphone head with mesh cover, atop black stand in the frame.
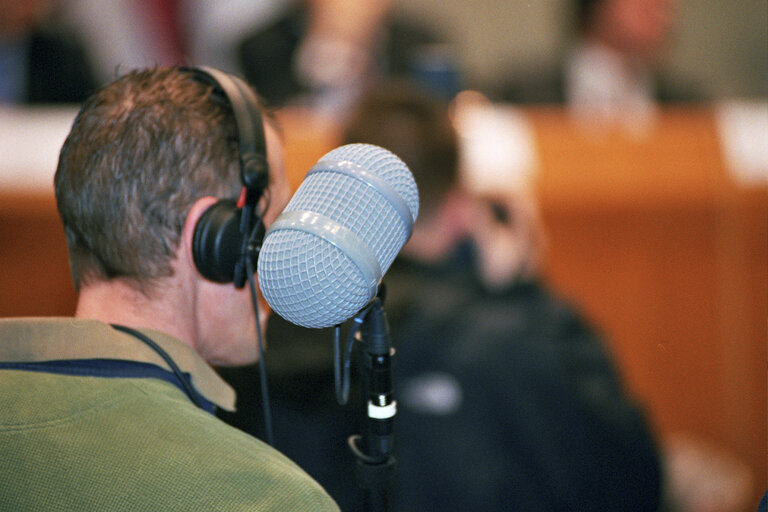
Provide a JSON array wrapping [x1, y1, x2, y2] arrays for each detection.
[[257, 144, 419, 328]]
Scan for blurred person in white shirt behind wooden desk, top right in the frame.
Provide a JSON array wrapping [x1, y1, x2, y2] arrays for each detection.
[[501, 0, 701, 132]]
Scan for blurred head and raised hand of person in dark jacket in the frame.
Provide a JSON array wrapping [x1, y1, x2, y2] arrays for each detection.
[[344, 81, 540, 288]]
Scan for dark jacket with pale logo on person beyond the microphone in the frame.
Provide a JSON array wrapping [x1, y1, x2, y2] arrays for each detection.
[[220, 242, 661, 512]]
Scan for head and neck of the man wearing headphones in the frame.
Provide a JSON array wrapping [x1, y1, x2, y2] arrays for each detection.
[[55, 68, 288, 365]]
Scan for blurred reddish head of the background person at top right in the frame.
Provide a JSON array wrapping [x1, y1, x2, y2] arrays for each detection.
[[575, 0, 679, 64]]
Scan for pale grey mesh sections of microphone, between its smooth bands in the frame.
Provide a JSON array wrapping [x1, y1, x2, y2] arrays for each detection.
[[258, 144, 418, 327]]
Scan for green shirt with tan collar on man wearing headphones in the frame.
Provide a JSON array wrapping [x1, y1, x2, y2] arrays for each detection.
[[0, 319, 338, 512]]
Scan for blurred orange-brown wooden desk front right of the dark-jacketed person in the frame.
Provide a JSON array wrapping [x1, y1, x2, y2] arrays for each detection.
[[529, 109, 768, 510]]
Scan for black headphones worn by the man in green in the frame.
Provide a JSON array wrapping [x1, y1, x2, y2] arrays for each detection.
[[180, 66, 269, 288]]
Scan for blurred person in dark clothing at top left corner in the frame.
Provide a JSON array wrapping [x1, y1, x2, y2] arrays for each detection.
[[0, 0, 96, 104]]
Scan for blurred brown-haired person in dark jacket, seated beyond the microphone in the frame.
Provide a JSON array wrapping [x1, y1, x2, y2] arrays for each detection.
[[219, 78, 662, 511]]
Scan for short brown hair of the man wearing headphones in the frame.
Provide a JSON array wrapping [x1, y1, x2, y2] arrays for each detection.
[[55, 68, 240, 293]]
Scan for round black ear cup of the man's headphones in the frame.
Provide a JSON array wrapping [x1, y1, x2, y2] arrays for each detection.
[[192, 199, 242, 283]]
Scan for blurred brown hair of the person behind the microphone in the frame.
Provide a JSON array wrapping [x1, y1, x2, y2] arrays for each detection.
[[344, 81, 458, 217]]
